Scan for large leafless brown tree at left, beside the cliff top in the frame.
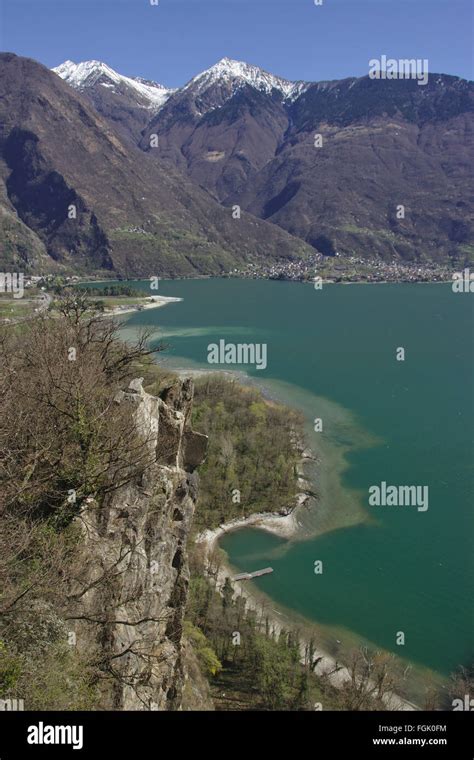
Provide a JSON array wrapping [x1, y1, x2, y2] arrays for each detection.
[[0, 296, 166, 520]]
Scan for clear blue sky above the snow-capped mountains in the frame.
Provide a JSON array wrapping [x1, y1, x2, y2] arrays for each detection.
[[0, 0, 474, 87]]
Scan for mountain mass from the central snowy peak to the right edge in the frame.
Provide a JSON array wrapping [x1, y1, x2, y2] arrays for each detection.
[[58, 59, 474, 262]]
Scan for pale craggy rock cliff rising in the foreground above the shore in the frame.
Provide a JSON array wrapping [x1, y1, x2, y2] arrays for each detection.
[[67, 378, 207, 710]]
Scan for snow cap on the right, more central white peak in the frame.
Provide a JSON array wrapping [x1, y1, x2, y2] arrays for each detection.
[[183, 58, 308, 100]]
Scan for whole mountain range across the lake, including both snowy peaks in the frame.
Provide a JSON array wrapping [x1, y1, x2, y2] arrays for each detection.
[[0, 53, 474, 276]]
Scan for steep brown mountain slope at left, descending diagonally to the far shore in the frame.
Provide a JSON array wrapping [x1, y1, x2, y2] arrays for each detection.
[[0, 53, 311, 277]]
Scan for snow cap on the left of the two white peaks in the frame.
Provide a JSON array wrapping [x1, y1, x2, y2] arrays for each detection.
[[53, 61, 174, 112]]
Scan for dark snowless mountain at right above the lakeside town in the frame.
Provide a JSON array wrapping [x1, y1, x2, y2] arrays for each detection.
[[231, 77, 474, 262]]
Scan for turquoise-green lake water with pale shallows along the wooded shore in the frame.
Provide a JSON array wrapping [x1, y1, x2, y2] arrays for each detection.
[[117, 279, 474, 674]]
